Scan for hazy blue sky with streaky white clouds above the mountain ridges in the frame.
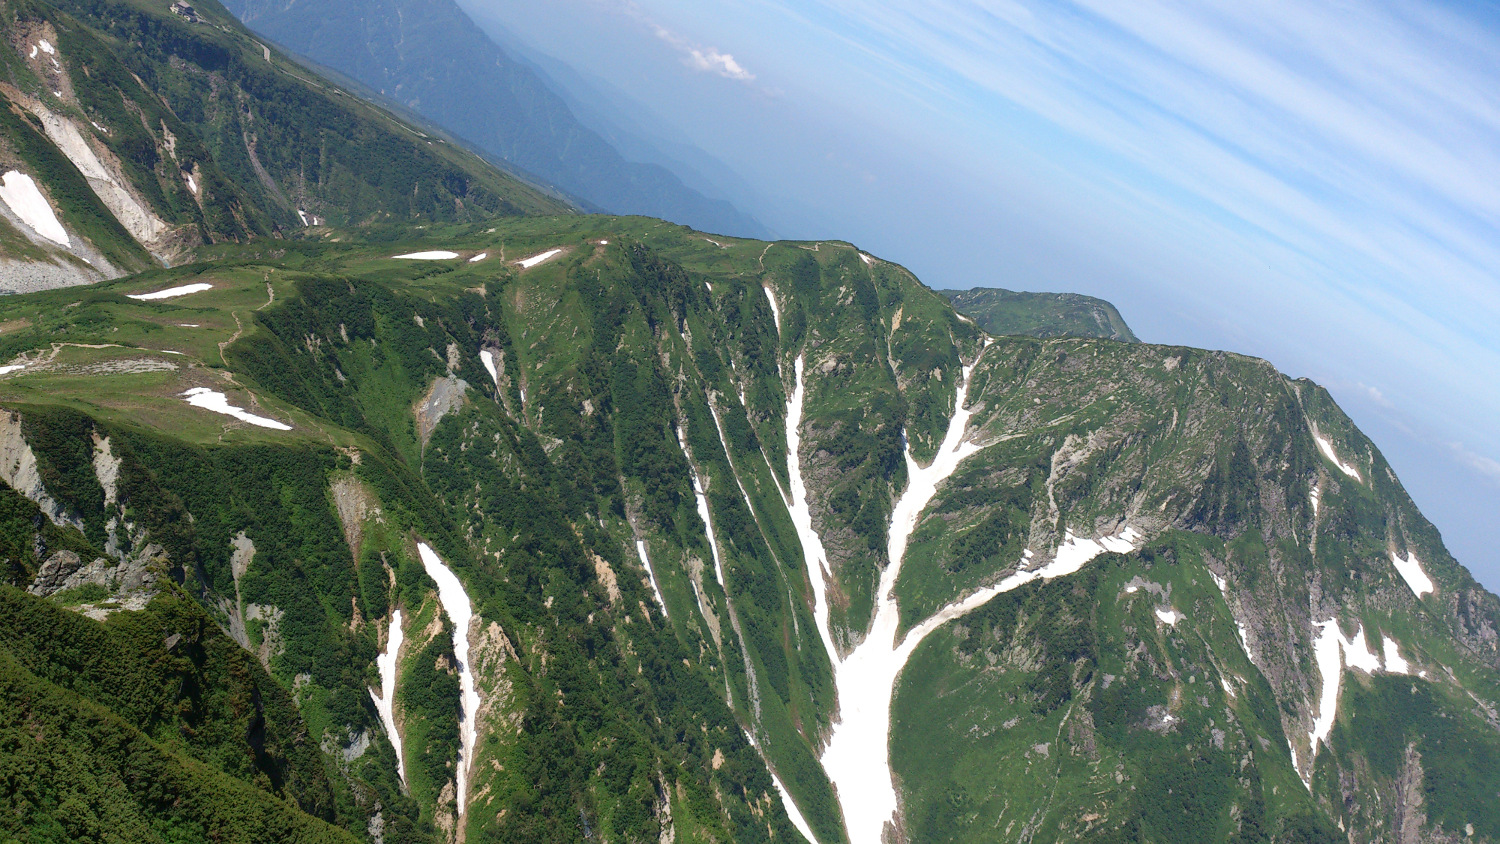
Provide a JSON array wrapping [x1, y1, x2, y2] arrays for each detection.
[[464, 0, 1500, 589]]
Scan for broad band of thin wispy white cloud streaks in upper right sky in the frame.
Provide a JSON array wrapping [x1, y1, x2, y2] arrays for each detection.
[[762, 0, 1500, 434]]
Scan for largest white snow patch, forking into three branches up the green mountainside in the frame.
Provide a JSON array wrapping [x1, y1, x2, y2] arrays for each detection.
[[786, 346, 1137, 844]]
